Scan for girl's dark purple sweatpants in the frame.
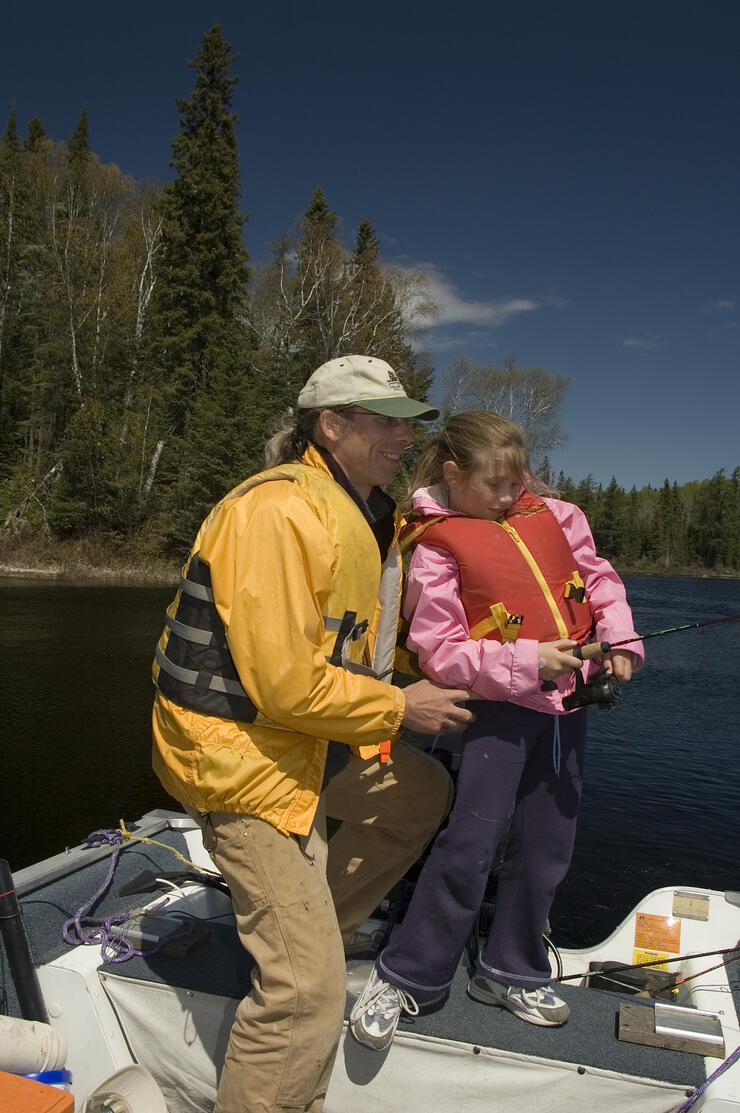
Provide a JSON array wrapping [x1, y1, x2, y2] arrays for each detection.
[[377, 700, 586, 1004]]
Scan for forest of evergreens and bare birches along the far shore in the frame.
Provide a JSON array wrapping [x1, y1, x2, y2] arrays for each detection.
[[0, 27, 740, 575]]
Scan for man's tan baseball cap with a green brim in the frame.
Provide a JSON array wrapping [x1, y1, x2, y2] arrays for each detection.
[[298, 355, 440, 421]]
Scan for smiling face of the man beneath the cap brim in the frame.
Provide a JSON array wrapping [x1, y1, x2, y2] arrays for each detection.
[[329, 410, 414, 499]]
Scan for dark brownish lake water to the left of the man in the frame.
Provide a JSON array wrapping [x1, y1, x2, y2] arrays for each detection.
[[0, 580, 174, 869]]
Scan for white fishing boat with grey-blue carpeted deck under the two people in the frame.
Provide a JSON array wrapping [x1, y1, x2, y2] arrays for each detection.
[[0, 810, 740, 1113]]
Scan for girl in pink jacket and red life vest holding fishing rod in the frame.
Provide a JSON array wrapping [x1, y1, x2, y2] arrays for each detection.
[[351, 411, 643, 1050]]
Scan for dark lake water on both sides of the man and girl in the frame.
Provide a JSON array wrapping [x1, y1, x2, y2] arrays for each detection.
[[0, 577, 740, 946]]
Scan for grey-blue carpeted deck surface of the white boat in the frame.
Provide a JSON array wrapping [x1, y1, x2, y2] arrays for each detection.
[[3, 830, 725, 1086]]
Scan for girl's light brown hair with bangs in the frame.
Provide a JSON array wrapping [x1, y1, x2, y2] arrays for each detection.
[[411, 410, 552, 494]]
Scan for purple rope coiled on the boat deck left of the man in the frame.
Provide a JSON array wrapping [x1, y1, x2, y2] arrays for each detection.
[[61, 830, 194, 963]]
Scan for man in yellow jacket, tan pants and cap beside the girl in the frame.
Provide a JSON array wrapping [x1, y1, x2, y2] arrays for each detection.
[[152, 355, 472, 1113]]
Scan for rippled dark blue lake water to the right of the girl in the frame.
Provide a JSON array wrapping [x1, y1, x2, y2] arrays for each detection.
[[552, 577, 740, 945]]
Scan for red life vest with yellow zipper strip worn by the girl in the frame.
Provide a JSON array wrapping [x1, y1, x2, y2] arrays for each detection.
[[414, 492, 593, 642]]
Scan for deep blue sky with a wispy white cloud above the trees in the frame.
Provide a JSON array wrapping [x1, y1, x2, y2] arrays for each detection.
[[0, 0, 740, 487]]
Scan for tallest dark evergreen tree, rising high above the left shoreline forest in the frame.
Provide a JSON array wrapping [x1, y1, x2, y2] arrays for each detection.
[[142, 26, 254, 544]]
